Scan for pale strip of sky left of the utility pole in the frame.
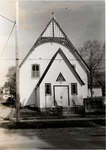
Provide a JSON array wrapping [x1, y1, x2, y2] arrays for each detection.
[[0, 0, 16, 86]]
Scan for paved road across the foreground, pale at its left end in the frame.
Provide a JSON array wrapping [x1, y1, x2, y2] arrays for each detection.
[[0, 127, 105, 150]]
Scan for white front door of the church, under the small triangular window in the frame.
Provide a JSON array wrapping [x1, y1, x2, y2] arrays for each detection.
[[54, 85, 69, 107]]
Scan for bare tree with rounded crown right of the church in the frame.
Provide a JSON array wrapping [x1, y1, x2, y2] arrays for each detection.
[[79, 40, 105, 97]]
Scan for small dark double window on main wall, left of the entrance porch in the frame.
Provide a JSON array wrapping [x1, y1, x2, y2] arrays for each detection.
[[32, 64, 40, 78]]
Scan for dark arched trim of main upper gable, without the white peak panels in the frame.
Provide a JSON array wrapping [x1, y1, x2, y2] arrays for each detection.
[[19, 17, 90, 73]]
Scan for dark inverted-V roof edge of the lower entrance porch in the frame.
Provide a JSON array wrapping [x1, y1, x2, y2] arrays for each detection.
[[35, 49, 84, 89]]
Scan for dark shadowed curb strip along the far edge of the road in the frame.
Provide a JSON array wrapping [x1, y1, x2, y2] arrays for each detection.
[[3, 117, 105, 129]]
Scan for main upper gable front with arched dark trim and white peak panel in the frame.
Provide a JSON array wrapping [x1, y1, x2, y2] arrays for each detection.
[[19, 17, 89, 73]]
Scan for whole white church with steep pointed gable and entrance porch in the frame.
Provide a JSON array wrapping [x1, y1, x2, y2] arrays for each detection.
[[19, 17, 89, 111]]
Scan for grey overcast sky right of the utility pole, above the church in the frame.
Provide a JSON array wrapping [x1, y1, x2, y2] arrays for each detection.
[[19, 0, 105, 57]]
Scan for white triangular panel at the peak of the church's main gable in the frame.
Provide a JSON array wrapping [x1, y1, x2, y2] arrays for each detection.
[[40, 17, 66, 38]]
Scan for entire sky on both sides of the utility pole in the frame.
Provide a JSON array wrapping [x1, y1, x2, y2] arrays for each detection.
[[0, 0, 105, 85]]
